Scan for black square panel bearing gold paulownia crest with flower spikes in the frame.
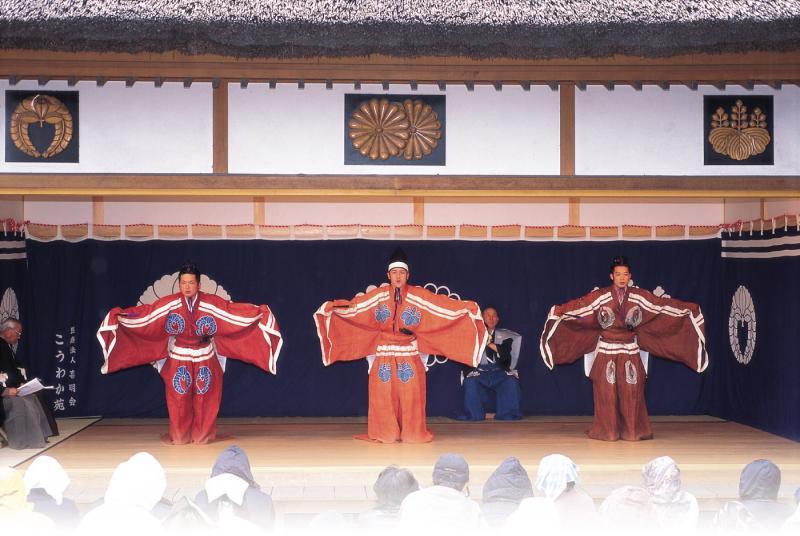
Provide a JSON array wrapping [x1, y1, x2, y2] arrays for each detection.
[[703, 95, 775, 166]]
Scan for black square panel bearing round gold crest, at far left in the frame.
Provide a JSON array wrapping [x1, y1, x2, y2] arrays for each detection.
[[5, 91, 79, 162]]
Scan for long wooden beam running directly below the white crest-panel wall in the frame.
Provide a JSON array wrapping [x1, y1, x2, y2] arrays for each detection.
[[0, 173, 800, 200]]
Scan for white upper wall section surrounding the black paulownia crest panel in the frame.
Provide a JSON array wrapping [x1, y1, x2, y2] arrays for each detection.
[[575, 85, 800, 175]]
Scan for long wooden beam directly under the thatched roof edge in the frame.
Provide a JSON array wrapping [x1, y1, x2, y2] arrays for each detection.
[[0, 50, 800, 85]]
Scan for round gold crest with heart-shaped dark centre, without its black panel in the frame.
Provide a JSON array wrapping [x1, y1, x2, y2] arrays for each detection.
[[9, 94, 73, 158]]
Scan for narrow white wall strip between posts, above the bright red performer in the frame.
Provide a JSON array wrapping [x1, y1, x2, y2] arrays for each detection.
[[103, 197, 253, 225]]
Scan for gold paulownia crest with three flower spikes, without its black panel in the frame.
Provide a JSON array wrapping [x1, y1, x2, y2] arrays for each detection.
[[708, 100, 770, 160]]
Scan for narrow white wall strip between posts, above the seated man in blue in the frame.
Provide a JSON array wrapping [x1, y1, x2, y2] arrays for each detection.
[[425, 198, 569, 225]]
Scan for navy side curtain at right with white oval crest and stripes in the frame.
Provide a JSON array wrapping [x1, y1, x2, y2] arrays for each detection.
[[711, 227, 800, 440]]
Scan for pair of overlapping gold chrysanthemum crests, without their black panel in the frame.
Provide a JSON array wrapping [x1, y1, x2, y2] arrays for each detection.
[[348, 98, 442, 160]]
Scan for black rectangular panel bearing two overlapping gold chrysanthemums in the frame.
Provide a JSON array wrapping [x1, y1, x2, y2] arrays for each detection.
[[344, 94, 445, 166]]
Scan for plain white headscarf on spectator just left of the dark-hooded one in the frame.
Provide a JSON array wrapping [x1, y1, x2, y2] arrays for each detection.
[[105, 452, 167, 512]]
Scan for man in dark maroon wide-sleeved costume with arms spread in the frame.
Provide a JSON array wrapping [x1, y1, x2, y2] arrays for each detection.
[[540, 257, 708, 441]]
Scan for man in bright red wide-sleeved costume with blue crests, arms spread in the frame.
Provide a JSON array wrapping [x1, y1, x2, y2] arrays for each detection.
[[97, 263, 283, 445]]
